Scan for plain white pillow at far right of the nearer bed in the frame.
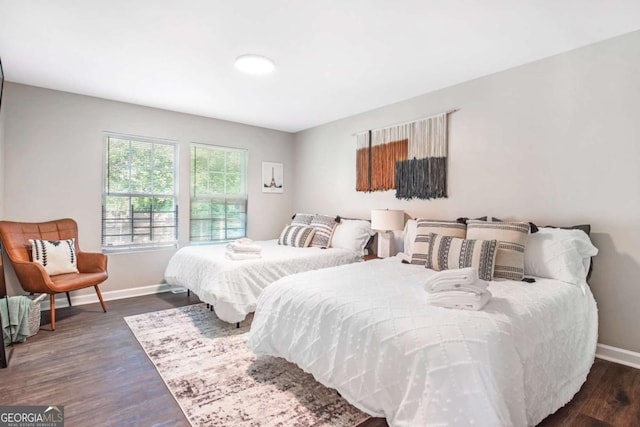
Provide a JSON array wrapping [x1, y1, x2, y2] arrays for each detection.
[[524, 227, 598, 285]]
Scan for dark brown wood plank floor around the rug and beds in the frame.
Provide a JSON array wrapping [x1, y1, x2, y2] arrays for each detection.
[[0, 293, 640, 427]]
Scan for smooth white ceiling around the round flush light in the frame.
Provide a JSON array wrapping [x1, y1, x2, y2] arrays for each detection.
[[0, 0, 640, 132]]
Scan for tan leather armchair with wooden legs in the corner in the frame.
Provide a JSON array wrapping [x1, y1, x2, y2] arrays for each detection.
[[0, 218, 108, 330]]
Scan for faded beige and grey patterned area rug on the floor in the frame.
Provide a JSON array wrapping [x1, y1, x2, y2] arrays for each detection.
[[125, 304, 369, 427]]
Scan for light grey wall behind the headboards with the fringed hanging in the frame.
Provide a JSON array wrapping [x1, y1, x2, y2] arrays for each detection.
[[294, 32, 640, 352]]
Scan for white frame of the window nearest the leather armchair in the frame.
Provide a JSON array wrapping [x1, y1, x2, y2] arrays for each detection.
[[101, 132, 180, 253]]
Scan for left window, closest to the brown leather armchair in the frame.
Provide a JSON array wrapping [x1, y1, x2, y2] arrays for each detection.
[[102, 134, 178, 251]]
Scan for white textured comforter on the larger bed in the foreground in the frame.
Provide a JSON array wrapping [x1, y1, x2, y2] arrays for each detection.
[[248, 258, 597, 426]]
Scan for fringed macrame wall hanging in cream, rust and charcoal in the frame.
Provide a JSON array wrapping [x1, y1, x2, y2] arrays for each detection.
[[356, 110, 456, 200]]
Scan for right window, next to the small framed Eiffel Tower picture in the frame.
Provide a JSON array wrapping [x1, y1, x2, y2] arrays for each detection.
[[190, 144, 247, 243]]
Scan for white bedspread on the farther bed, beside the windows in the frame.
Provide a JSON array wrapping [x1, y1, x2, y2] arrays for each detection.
[[164, 240, 362, 323]]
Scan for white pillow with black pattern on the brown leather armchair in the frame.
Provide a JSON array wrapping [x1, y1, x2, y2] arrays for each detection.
[[29, 239, 78, 276]]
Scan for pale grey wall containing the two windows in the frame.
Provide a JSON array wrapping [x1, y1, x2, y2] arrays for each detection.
[[2, 83, 294, 294]]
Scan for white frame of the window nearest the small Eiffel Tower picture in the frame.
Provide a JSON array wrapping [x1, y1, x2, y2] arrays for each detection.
[[189, 142, 249, 245]]
